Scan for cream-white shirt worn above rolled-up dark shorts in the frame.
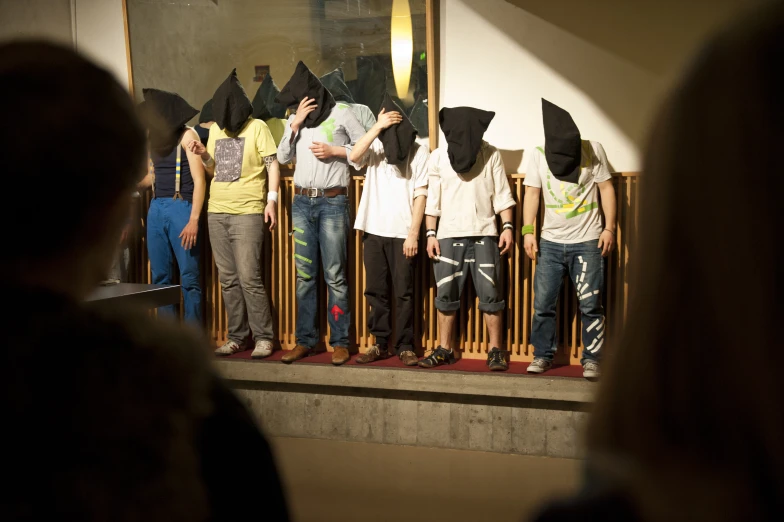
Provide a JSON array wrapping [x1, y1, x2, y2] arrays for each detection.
[[425, 141, 515, 239]]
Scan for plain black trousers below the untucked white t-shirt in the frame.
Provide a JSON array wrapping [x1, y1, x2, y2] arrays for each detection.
[[364, 234, 414, 354]]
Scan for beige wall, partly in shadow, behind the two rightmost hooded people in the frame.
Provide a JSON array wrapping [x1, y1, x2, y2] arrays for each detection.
[[440, 0, 756, 172]]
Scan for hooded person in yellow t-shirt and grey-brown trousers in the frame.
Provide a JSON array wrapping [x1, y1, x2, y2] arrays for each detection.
[[191, 69, 280, 359]]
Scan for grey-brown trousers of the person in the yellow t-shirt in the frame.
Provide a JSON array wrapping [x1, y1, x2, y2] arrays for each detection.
[[207, 214, 275, 344]]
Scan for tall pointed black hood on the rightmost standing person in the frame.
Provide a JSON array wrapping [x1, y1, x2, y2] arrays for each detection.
[[542, 98, 582, 183]]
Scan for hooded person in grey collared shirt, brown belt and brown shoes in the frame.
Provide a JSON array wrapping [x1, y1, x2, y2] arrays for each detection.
[[276, 62, 365, 365]]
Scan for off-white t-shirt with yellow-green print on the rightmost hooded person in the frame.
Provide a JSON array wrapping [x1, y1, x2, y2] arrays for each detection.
[[524, 140, 612, 244]]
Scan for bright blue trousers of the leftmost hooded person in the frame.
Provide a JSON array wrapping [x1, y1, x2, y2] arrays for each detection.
[[147, 198, 201, 323]]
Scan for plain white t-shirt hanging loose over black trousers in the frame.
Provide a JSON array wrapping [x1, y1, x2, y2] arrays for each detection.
[[352, 139, 430, 239]]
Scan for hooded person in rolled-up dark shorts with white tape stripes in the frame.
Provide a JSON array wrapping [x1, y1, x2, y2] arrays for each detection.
[[419, 107, 515, 371]]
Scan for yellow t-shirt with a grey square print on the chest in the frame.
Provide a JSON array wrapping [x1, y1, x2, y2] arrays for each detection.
[[207, 119, 278, 214]]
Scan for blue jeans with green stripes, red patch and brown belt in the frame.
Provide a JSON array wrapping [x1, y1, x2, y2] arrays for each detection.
[[291, 195, 351, 349]]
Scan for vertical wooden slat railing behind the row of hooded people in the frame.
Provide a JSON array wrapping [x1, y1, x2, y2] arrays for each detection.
[[131, 169, 639, 364]]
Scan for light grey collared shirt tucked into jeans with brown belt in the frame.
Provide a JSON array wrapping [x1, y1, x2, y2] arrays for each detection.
[[278, 103, 365, 189]]
